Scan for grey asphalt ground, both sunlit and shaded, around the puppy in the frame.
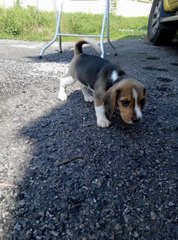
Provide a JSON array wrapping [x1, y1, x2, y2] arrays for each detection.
[[0, 40, 178, 240]]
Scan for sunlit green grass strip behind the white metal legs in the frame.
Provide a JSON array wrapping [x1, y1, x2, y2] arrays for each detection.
[[0, 6, 148, 41]]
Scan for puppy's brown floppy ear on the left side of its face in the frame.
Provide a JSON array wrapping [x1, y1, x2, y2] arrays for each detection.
[[104, 87, 120, 115]]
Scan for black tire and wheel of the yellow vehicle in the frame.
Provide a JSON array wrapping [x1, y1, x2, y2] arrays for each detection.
[[147, 0, 177, 45]]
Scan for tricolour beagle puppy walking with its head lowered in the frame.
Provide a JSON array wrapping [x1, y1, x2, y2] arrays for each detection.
[[58, 40, 146, 128]]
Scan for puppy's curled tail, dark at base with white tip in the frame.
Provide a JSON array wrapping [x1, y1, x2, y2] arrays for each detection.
[[74, 39, 101, 56]]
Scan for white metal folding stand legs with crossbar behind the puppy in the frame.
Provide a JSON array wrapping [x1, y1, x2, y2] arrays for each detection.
[[39, 0, 117, 58]]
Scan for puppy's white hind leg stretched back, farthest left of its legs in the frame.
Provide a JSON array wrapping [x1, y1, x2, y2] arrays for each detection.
[[58, 76, 75, 101]]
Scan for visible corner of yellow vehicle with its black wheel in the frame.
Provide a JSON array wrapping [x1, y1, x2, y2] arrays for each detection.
[[148, 0, 178, 45]]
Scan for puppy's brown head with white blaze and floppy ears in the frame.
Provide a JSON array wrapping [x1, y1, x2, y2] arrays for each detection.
[[104, 79, 146, 124]]
